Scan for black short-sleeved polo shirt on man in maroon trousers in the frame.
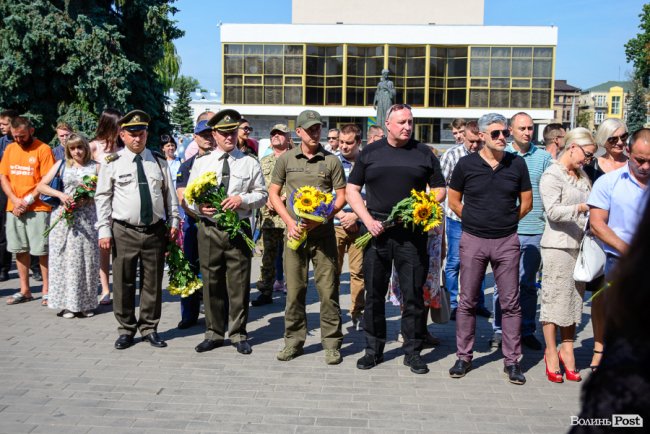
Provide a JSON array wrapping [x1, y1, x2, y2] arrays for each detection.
[[449, 152, 532, 238]]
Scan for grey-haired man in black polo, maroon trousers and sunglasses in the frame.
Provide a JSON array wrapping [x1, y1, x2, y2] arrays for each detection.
[[448, 113, 533, 384]]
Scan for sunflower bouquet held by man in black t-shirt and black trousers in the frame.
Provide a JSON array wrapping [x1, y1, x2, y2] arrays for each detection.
[[354, 190, 442, 249]]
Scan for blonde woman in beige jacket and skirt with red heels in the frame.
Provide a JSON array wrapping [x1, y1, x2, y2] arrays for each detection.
[[539, 128, 598, 383]]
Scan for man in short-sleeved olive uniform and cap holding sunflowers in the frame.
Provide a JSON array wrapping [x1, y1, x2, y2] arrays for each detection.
[[269, 110, 345, 365]]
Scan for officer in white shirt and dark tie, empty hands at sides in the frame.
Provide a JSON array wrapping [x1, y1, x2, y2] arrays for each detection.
[[95, 110, 179, 350]]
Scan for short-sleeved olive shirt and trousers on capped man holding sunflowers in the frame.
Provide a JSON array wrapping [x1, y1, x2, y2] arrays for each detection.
[[271, 141, 345, 350]]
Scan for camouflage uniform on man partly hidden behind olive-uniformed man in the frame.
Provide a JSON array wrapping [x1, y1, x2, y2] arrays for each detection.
[[257, 154, 287, 295]]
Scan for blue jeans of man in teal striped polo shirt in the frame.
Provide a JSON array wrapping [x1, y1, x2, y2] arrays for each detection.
[[492, 234, 542, 337]]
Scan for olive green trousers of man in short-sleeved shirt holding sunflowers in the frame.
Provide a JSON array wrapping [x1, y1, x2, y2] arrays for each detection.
[[284, 230, 343, 350]]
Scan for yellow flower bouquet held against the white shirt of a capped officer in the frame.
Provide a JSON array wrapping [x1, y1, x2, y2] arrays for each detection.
[[185, 172, 255, 250]]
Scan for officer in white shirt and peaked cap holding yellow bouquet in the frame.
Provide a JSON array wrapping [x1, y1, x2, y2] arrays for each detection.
[[188, 109, 268, 354]]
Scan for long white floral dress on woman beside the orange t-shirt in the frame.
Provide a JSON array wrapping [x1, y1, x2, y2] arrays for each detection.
[[48, 161, 99, 312]]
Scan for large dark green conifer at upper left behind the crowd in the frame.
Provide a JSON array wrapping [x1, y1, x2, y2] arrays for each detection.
[[0, 0, 183, 140]]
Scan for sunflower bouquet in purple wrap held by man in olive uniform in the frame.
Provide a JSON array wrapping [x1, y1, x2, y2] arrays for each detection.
[[287, 185, 334, 250]]
